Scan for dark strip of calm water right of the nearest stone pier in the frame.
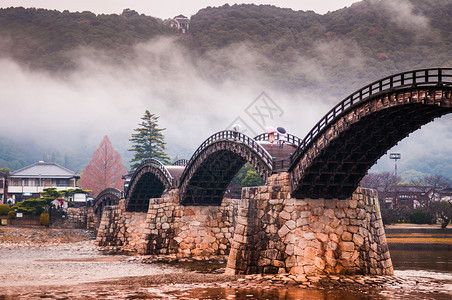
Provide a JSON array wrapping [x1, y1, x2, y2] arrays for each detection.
[[390, 250, 452, 273]]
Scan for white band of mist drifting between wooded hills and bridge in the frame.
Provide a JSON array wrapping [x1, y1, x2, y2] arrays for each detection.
[[0, 26, 452, 178]]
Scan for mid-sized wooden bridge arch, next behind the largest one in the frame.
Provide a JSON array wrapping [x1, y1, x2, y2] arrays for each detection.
[[179, 130, 273, 205]]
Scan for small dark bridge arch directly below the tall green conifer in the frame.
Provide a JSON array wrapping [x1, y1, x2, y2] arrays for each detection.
[[125, 158, 173, 212]]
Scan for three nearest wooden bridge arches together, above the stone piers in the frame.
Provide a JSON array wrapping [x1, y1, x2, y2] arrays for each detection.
[[120, 68, 452, 211]]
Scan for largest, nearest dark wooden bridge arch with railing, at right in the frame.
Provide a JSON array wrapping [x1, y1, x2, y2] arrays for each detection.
[[289, 68, 452, 198]]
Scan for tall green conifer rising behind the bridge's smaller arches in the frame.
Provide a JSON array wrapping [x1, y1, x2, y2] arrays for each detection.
[[129, 110, 170, 169]]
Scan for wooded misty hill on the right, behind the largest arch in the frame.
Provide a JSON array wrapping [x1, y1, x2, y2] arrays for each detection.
[[191, 0, 452, 88]]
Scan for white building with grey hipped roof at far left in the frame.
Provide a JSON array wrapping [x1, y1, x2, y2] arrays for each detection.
[[7, 161, 80, 203]]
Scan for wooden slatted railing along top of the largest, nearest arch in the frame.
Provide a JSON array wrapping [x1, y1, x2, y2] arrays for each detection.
[[292, 68, 452, 167]]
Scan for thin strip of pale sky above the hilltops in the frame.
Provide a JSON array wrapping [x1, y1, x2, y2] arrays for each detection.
[[0, 0, 358, 19]]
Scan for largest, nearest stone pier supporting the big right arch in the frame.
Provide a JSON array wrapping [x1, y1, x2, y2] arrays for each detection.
[[226, 173, 393, 275]]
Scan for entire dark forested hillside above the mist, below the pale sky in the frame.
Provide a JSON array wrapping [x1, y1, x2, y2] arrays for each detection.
[[0, 0, 452, 88]]
